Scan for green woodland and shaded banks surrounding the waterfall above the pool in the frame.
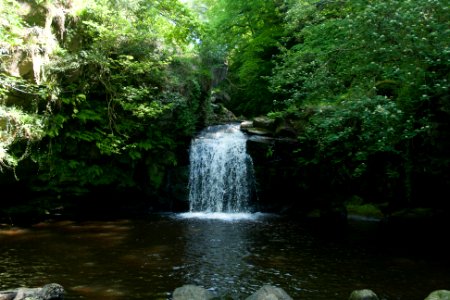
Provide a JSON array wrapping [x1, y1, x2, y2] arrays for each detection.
[[0, 0, 450, 224]]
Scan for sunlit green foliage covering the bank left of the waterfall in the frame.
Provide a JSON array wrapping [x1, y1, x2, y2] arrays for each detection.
[[0, 0, 201, 202]]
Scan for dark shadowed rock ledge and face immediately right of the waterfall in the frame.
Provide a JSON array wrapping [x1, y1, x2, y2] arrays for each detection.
[[241, 110, 347, 220]]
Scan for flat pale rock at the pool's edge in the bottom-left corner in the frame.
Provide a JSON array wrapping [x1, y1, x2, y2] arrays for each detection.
[[0, 283, 64, 300]]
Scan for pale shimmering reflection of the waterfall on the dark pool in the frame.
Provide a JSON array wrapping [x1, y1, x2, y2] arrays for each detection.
[[184, 220, 255, 294]]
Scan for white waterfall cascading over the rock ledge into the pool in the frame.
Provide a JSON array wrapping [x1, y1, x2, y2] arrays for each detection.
[[189, 124, 253, 213]]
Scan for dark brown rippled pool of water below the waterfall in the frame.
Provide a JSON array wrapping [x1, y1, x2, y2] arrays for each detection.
[[0, 214, 450, 300]]
